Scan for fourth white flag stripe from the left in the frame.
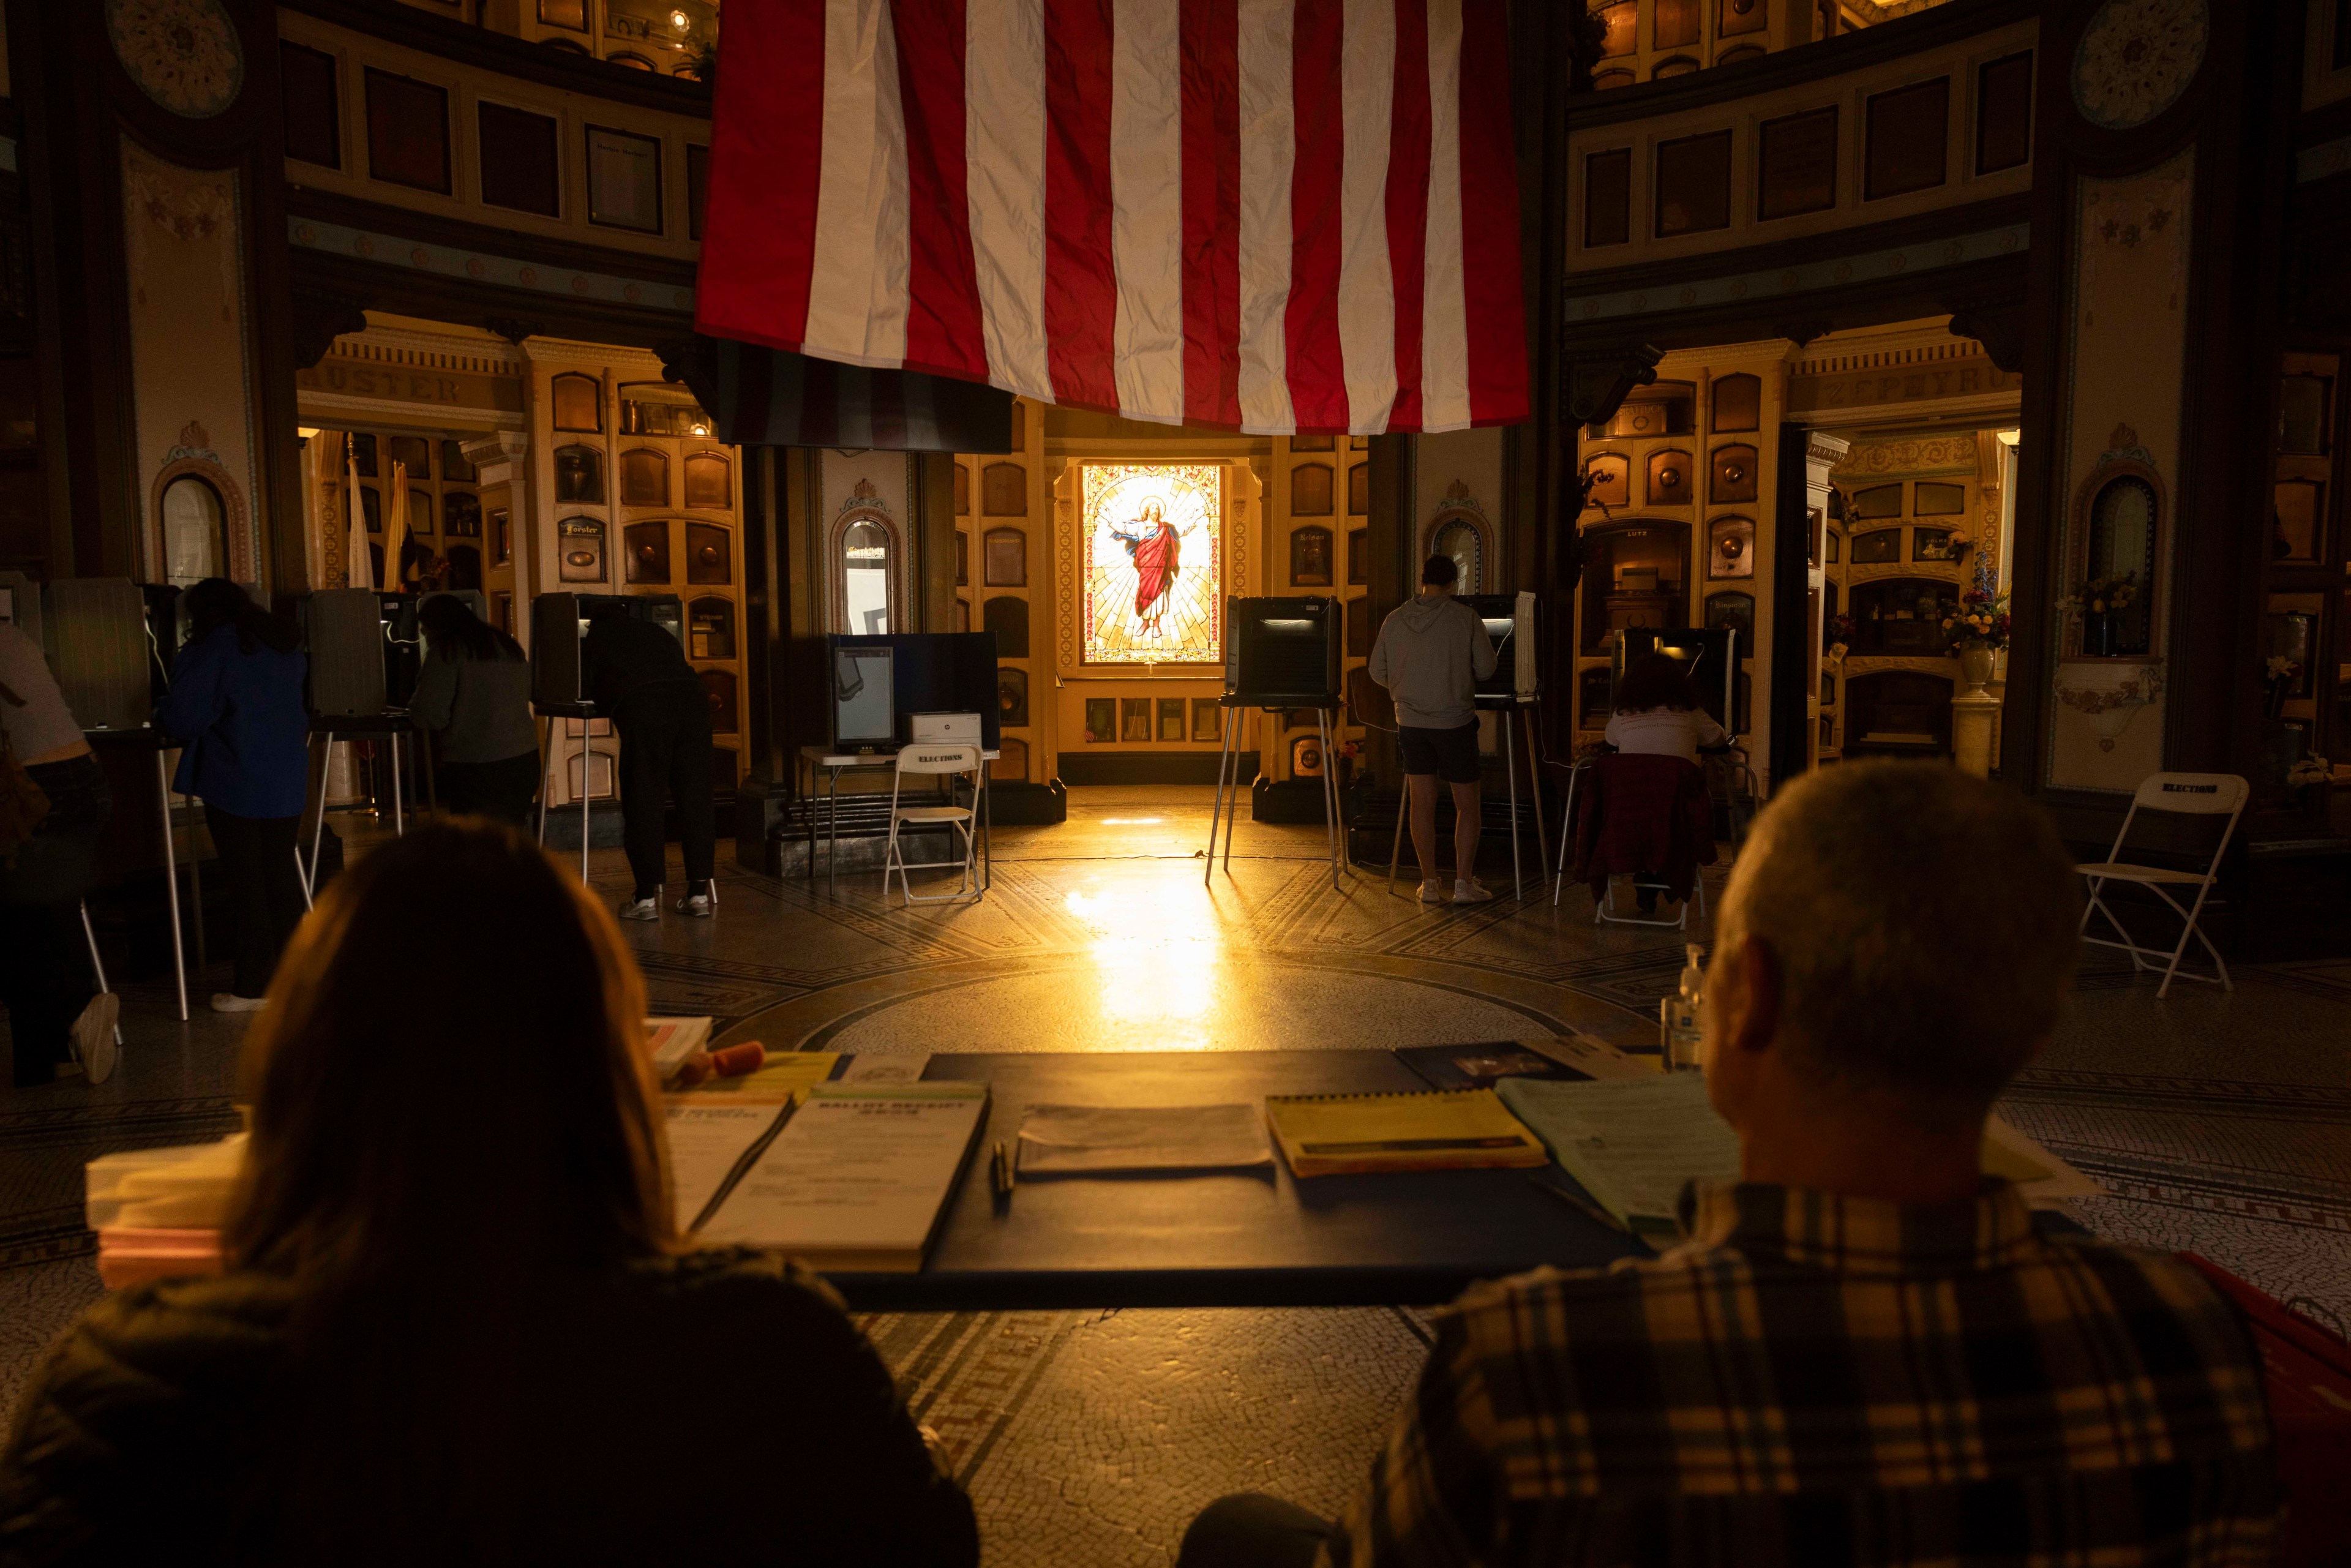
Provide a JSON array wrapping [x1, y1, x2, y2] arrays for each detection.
[[1239, 0, 1298, 435]]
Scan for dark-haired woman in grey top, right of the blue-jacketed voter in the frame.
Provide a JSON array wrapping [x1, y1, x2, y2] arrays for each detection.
[[409, 593, 541, 828]]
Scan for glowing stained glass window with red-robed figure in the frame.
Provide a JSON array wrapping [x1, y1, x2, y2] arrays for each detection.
[[1084, 463, 1225, 667]]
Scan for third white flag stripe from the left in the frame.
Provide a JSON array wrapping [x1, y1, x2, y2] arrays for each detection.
[[1109, 0, 1183, 426]]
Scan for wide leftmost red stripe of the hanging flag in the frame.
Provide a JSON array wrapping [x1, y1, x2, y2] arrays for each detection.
[[694, 5, 825, 348]]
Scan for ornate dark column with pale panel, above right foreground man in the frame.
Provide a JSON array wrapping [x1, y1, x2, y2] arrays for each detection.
[[2012, 0, 2300, 822]]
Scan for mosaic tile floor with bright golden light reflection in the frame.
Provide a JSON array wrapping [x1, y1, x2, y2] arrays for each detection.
[[0, 787, 2351, 1568]]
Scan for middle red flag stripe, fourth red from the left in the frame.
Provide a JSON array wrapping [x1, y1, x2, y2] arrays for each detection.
[[1183, 0, 1242, 430]]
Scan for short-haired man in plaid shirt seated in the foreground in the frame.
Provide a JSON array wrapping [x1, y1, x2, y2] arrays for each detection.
[[1178, 762, 2281, 1568]]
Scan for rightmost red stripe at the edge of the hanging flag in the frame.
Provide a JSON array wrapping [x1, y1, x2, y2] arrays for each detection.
[[1460, 0, 1526, 426]]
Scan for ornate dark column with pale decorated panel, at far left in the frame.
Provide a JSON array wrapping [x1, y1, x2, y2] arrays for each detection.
[[7, 0, 308, 599]]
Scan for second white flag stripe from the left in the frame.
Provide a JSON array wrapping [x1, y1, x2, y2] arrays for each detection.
[[964, 0, 1053, 402]]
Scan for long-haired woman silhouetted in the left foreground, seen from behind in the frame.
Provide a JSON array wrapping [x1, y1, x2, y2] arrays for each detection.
[[0, 820, 978, 1568]]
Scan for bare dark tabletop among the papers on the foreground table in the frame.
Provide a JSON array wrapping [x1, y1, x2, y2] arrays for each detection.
[[830, 1051, 1646, 1311]]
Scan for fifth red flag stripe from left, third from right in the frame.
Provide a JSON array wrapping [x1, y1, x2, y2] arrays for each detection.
[[1281, 0, 1347, 432]]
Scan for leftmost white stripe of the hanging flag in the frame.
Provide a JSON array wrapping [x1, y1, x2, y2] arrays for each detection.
[[801, 0, 910, 369]]
